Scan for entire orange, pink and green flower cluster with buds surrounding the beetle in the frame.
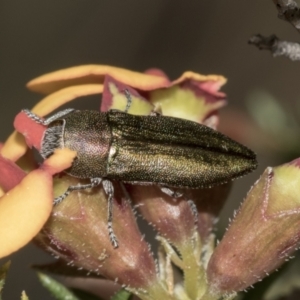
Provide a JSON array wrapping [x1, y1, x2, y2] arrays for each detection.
[[0, 65, 300, 300]]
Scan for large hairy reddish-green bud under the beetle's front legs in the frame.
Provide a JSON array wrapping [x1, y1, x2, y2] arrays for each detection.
[[36, 176, 156, 289]]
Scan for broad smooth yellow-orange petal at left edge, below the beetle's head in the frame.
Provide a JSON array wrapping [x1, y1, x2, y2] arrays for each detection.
[[0, 169, 53, 258]]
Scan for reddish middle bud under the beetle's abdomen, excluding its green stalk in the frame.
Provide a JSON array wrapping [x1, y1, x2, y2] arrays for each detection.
[[127, 183, 231, 246]]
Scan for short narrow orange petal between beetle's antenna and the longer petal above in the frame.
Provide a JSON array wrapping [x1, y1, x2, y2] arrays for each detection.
[[32, 84, 103, 117]]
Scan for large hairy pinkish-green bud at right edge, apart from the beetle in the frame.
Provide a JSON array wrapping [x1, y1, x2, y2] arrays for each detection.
[[207, 159, 300, 295]]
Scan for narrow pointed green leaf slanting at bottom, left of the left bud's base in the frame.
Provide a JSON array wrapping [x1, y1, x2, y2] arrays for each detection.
[[37, 273, 81, 300]]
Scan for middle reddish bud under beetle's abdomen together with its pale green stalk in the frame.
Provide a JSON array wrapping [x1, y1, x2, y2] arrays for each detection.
[[127, 184, 230, 299]]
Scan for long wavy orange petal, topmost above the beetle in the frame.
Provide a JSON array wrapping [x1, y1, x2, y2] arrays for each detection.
[[27, 65, 170, 94]]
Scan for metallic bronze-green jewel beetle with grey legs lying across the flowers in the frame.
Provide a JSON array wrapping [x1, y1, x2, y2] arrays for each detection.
[[24, 103, 257, 247]]
